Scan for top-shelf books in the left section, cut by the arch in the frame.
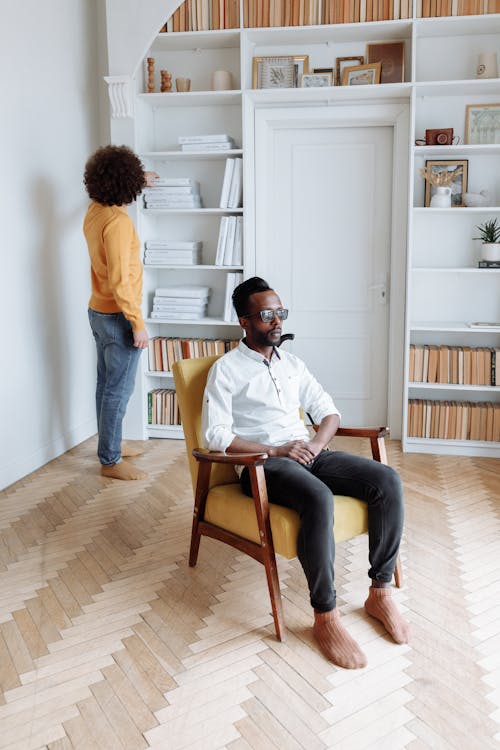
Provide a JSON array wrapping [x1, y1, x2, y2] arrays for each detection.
[[160, 0, 240, 33]]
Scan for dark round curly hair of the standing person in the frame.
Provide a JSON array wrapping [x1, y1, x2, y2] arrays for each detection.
[[83, 145, 146, 206]]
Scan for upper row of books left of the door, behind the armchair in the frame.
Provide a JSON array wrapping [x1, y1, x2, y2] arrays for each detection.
[[148, 336, 238, 372]]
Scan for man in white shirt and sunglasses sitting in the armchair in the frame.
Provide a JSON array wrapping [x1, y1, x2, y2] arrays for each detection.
[[202, 277, 409, 669]]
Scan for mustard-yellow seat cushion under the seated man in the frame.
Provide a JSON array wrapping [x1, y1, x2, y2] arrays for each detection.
[[205, 484, 368, 560]]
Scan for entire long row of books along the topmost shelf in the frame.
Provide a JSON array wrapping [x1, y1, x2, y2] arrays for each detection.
[[161, 0, 499, 32]]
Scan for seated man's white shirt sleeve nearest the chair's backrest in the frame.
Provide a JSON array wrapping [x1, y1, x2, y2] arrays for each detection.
[[201, 362, 236, 451]]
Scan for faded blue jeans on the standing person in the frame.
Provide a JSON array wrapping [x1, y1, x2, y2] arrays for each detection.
[[89, 309, 142, 466]]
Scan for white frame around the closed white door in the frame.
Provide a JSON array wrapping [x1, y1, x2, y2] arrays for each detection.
[[243, 97, 410, 439]]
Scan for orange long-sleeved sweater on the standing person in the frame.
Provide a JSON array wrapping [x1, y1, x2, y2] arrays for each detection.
[[83, 202, 145, 331]]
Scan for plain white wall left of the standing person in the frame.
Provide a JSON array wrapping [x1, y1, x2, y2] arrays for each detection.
[[0, 0, 109, 487]]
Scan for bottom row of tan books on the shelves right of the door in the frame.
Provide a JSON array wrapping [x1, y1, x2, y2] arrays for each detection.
[[408, 399, 500, 442]]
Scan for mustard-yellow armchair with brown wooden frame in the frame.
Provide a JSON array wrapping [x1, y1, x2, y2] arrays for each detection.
[[172, 356, 402, 640]]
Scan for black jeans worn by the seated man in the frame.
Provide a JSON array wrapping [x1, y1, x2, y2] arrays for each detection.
[[241, 450, 404, 612]]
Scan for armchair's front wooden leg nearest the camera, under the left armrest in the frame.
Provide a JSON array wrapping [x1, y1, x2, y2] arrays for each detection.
[[249, 466, 285, 641]]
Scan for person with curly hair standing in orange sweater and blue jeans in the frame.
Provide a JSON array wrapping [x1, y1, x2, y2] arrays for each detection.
[[83, 146, 157, 479]]
